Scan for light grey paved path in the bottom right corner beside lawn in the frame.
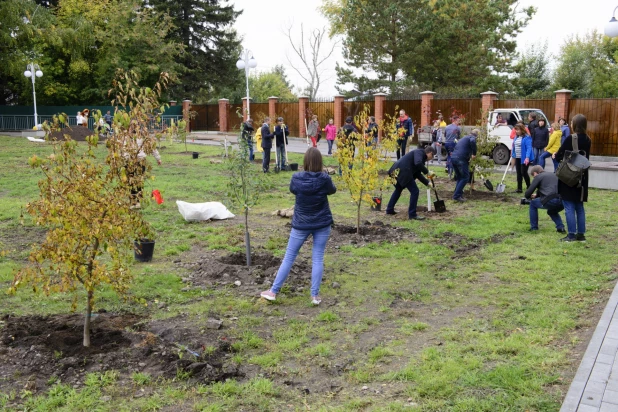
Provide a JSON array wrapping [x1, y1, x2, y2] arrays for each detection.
[[560, 284, 618, 412]]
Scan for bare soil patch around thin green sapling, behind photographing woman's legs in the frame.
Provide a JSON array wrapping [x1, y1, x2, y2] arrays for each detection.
[[178, 252, 311, 296]]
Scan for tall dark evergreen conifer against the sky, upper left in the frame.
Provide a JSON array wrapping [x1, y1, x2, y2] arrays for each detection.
[[145, 0, 242, 100]]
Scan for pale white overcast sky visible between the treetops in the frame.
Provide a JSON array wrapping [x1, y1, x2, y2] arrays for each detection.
[[229, 0, 618, 97]]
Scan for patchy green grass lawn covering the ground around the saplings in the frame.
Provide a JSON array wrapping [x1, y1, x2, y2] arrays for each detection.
[[0, 136, 618, 412]]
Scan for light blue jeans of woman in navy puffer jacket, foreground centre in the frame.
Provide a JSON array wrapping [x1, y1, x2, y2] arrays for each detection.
[[270, 226, 330, 296]]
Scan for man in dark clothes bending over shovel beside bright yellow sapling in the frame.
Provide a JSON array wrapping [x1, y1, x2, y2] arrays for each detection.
[[386, 146, 436, 220]]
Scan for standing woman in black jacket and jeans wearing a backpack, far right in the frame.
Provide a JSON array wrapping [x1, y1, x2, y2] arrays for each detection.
[[554, 114, 592, 242]]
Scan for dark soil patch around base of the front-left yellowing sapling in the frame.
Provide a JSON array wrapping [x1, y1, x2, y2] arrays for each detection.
[[0, 313, 239, 392]]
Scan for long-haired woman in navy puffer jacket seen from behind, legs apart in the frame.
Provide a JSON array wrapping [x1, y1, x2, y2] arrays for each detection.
[[260, 147, 337, 305]]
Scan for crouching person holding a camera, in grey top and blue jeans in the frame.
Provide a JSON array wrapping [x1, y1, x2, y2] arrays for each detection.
[[521, 165, 565, 233]]
